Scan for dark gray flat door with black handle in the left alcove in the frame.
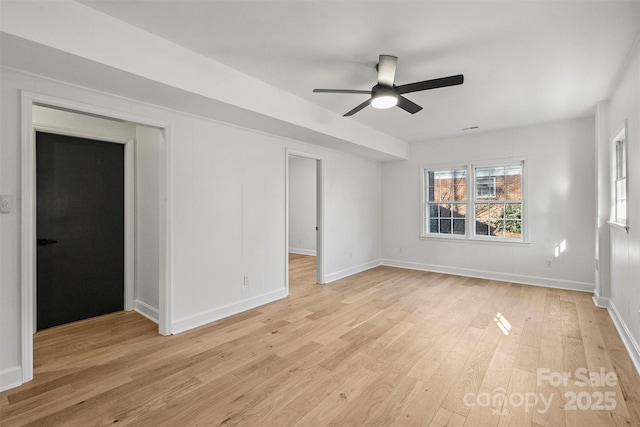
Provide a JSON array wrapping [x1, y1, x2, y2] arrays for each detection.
[[36, 132, 124, 330]]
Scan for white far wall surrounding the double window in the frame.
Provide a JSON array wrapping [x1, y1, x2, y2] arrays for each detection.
[[382, 119, 595, 291]]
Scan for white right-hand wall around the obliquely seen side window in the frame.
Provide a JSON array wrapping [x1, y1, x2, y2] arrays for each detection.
[[598, 44, 640, 371]]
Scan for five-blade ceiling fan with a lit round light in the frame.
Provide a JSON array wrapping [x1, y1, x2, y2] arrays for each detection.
[[313, 55, 464, 117]]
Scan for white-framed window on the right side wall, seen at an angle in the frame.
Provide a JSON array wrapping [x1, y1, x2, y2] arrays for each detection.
[[609, 120, 629, 232]]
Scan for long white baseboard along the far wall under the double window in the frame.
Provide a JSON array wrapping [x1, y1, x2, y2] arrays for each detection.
[[380, 259, 595, 292]]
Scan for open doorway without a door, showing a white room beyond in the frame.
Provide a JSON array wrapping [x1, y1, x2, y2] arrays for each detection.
[[285, 150, 325, 288]]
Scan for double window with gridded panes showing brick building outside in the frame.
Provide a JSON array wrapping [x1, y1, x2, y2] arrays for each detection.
[[421, 160, 524, 241]]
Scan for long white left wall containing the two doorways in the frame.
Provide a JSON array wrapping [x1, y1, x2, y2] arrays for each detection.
[[0, 69, 381, 389]]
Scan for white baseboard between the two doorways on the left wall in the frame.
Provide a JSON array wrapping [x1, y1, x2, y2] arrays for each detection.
[[171, 288, 288, 334]]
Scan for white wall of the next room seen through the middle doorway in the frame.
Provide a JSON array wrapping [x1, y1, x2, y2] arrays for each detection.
[[289, 156, 317, 255]]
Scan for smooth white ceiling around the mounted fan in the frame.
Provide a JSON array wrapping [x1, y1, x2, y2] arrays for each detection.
[[82, 0, 640, 142]]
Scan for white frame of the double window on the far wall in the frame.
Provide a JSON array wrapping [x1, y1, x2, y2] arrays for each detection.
[[419, 157, 529, 244]]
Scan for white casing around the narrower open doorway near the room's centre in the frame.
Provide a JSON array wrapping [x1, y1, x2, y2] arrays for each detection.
[[284, 148, 326, 291]]
